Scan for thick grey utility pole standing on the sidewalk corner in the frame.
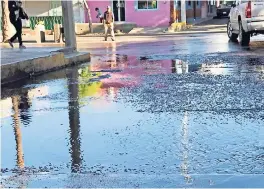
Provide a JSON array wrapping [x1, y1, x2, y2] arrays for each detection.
[[61, 0, 76, 51]]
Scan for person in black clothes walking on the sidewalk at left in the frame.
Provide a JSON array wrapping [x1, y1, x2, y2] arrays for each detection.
[[8, 1, 28, 49]]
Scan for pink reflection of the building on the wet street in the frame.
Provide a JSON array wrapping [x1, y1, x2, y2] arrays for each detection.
[[90, 56, 172, 88]]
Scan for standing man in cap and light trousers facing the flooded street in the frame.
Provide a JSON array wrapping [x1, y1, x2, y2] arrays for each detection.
[[104, 6, 115, 41]]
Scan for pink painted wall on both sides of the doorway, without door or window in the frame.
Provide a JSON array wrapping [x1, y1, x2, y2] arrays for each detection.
[[85, 0, 170, 27]]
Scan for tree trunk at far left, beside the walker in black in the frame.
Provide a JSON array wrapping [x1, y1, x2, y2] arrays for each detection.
[[1, 0, 9, 42]]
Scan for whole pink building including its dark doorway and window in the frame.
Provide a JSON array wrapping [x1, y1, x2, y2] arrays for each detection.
[[86, 0, 170, 27]]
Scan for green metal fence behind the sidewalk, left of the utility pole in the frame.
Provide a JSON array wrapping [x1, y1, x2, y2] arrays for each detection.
[[29, 16, 63, 30]]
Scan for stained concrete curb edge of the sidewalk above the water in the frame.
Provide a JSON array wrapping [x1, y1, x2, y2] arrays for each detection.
[[1, 52, 90, 85]]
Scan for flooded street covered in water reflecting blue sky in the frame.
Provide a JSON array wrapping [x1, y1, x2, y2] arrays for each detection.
[[1, 34, 264, 188]]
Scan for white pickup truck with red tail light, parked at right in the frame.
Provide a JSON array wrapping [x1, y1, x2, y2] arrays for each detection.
[[227, 0, 264, 46]]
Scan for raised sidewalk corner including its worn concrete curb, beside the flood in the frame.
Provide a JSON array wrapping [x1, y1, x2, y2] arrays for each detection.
[[1, 46, 90, 85]]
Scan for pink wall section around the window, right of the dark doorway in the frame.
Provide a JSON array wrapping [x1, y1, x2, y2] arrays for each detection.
[[126, 0, 170, 27]]
